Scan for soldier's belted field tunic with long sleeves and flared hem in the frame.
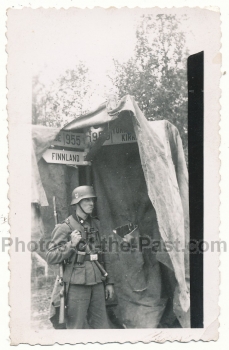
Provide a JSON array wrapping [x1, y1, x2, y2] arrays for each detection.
[[47, 215, 113, 285]]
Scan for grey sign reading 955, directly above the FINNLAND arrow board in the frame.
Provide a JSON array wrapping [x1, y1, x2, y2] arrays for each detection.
[[52, 131, 85, 149]]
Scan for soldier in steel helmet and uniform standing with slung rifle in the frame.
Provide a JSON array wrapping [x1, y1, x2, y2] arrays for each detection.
[[47, 186, 114, 329]]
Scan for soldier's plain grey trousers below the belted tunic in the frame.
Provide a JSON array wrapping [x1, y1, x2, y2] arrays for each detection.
[[66, 283, 110, 329]]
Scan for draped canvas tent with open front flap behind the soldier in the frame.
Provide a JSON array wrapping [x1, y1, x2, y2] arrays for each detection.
[[32, 96, 190, 328]]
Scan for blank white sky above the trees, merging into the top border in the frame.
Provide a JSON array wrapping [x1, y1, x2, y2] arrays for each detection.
[[28, 8, 220, 108]]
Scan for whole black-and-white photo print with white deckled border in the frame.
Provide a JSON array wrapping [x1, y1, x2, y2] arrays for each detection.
[[8, 7, 220, 345]]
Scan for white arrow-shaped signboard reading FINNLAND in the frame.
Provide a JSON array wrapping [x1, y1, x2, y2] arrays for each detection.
[[43, 149, 90, 165]]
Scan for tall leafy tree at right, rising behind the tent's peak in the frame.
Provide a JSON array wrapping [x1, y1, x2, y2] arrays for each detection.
[[112, 14, 188, 156]]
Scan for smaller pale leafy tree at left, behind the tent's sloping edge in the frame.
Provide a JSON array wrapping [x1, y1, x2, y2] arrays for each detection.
[[32, 63, 90, 127]]
